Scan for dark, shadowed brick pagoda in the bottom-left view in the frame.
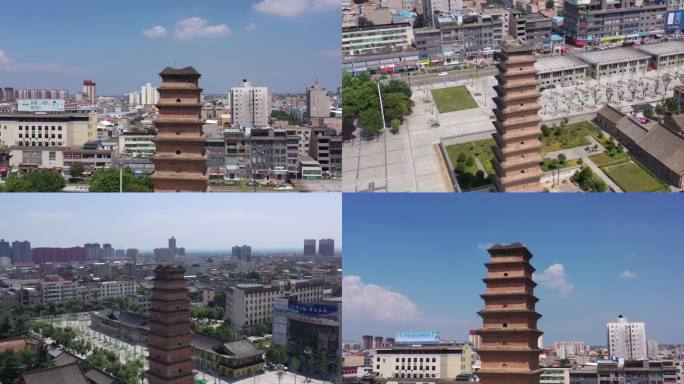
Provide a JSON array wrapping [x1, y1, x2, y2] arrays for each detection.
[[147, 265, 194, 384]]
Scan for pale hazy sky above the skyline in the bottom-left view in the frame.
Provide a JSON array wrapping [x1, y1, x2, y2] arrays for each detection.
[[0, 193, 342, 250]]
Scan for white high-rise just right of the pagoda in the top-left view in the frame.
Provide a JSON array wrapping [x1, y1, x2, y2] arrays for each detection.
[[230, 79, 271, 128]]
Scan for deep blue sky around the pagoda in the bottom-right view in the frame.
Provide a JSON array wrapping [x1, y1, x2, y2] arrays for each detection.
[[343, 193, 684, 345]]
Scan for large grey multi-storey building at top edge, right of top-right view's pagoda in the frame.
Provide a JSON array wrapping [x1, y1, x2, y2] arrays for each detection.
[[563, 0, 667, 46]]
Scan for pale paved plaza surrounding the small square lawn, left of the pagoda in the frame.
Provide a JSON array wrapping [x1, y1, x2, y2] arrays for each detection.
[[342, 77, 496, 192]]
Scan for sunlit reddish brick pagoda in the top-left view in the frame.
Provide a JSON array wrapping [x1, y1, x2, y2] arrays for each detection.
[[150, 67, 209, 192]]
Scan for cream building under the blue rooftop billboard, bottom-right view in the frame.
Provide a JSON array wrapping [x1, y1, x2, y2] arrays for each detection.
[[370, 344, 472, 380]]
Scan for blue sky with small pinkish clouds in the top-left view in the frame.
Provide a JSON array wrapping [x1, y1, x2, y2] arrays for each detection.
[[0, 0, 341, 95]]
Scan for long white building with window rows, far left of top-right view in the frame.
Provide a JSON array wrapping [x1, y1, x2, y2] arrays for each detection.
[[342, 23, 414, 57]]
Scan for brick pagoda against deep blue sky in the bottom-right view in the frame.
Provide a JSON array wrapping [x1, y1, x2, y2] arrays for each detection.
[[477, 243, 542, 384]]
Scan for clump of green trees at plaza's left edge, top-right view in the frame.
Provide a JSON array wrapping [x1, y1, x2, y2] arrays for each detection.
[[342, 72, 414, 136]]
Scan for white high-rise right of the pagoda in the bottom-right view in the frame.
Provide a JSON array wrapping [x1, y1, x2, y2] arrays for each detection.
[[606, 315, 648, 360]]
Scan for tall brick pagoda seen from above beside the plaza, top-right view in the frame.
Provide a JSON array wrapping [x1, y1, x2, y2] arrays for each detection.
[[493, 41, 543, 192]]
